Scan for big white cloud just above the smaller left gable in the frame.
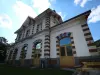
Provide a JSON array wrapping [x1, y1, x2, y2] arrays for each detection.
[[13, 1, 37, 23]]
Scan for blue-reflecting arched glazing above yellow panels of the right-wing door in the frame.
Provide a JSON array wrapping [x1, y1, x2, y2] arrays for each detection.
[[60, 37, 73, 56]]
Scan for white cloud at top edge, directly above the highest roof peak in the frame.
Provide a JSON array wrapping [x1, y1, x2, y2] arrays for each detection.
[[33, 0, 51, 14]]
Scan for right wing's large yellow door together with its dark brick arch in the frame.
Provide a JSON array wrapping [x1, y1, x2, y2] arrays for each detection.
[[57, 32, 74, 67]]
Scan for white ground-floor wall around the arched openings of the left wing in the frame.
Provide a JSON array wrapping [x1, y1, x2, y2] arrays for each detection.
[[15, 31, 45, 60]]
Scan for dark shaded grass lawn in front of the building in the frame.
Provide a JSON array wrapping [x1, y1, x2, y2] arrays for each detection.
[[0, 65, 73, 75]]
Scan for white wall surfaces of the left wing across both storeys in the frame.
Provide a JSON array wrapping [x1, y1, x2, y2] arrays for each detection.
[[15, 17, 46, 60]]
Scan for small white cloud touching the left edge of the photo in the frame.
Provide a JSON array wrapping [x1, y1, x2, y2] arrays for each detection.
[[0, 14, 12, 29]]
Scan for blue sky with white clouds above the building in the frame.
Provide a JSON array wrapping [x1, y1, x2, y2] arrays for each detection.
[[0, 0, 100, 43]]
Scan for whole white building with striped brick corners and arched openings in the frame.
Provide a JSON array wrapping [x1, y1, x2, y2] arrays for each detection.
[[7, 8, 97, 67]]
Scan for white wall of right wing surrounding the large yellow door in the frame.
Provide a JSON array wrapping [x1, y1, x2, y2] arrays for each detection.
[[50, 19, 90, 58]]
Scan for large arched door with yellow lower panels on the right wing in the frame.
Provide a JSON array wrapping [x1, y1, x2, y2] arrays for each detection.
[[60, 37, 74, 67]]
